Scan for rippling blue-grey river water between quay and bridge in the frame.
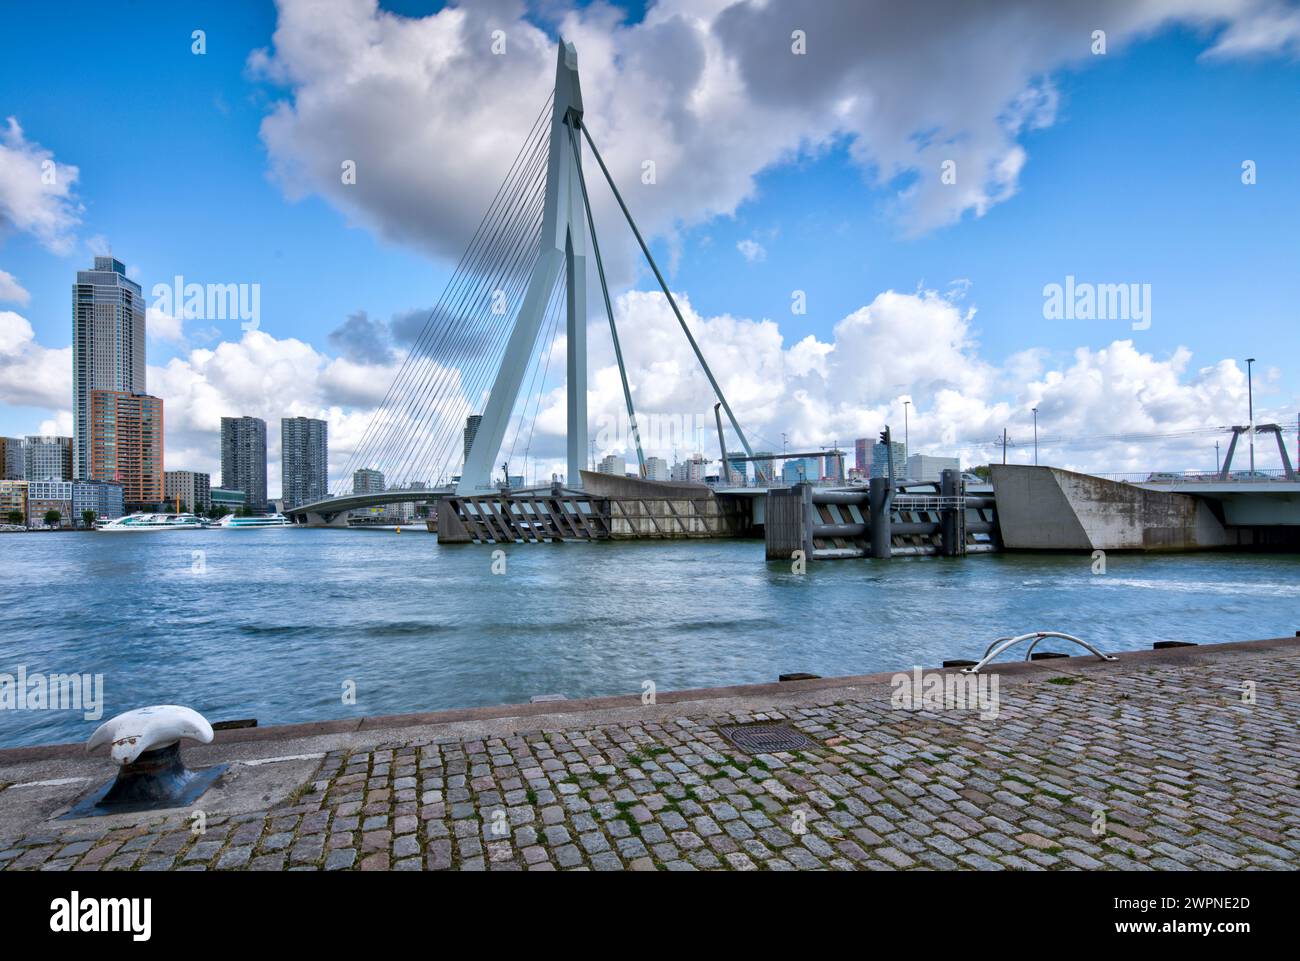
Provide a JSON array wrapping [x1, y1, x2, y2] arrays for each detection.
[[0, 529, 1300, 746]]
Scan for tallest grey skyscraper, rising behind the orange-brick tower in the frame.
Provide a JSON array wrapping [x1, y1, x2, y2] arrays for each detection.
[[73, 257, 146, 480]]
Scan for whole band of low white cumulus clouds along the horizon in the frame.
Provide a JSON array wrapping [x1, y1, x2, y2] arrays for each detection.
[[0, 290, 1296, 492]]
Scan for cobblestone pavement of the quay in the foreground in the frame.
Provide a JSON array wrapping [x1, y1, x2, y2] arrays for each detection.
[[0, 649, 1300, 871]]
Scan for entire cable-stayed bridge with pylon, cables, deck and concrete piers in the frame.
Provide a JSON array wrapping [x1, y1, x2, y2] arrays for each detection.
[[286, 43, 1300, 559]]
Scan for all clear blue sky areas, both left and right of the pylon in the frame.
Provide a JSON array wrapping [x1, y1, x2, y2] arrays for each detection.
[[0, 3, 1300, 481]]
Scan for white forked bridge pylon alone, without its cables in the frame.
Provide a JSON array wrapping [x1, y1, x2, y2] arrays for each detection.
[[456, 43, 588, 495]]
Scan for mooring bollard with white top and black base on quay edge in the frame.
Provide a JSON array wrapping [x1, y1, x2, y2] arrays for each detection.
[[64, 704, 228, 819]]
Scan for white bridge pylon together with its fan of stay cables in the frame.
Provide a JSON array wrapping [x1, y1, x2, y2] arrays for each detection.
[[287, 42, 754, 523]]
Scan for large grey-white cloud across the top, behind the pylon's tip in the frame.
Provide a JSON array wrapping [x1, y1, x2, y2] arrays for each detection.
[[250, 0, 1300, 262]]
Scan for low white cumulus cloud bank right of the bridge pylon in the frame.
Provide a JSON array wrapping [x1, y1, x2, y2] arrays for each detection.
[[507, 291, 1294, 481]]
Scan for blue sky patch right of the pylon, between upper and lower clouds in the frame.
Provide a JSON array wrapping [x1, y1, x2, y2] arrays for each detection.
[[702, 35, 1300, 365]]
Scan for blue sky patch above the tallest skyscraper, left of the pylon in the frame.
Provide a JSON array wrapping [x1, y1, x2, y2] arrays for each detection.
[[0, 4, 426, 364]]
